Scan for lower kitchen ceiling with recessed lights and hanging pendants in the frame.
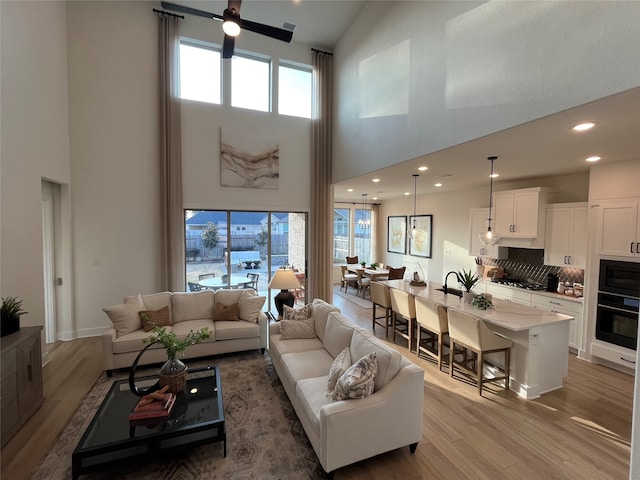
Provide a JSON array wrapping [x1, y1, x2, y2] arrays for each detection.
[[334, 88, 640, 201]]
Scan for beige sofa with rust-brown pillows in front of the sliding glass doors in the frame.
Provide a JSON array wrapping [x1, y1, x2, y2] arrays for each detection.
[[102, 289, 268, 376]]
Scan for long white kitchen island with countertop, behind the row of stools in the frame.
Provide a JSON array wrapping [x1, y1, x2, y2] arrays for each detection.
[[379, 280, 574, 400]]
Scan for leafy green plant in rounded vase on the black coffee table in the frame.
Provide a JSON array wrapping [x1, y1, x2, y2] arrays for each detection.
[[142, 324, 210, 393]]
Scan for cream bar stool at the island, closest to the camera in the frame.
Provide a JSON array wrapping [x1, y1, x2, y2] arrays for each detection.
[[447, 308, 513, 395]]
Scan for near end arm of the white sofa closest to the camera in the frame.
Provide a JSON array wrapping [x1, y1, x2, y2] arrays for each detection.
[[320, 364, 424, 472]]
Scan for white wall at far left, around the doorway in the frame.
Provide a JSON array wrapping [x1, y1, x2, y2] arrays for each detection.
[[0, 2, 70, 342]]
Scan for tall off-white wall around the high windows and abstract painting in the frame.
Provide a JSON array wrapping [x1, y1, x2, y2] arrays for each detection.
[[68, 2, 311, 336]]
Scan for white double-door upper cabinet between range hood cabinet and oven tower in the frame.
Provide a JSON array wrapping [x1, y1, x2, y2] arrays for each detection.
[[544, 203, 588, 269]]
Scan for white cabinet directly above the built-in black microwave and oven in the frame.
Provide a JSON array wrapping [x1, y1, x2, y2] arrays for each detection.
[[596, 199, 640, 258]]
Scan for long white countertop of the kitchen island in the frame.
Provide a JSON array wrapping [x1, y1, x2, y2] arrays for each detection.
[[379, 280, 579, 332]]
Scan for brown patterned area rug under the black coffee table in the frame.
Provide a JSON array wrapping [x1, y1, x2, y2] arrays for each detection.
[[32, 350, 326, 480]]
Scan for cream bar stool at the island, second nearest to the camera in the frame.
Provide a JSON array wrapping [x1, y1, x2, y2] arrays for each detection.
[[416, 297, 449, 371]]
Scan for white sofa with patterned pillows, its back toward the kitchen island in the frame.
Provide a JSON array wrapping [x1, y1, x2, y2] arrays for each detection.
[[269, 299, 424, 474]]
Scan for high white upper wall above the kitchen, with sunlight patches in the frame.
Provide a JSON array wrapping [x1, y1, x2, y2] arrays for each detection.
[[333, 1, 640, 182]]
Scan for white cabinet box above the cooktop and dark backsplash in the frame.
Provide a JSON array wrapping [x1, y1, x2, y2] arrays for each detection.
[[493, 187, 551, 248]]
